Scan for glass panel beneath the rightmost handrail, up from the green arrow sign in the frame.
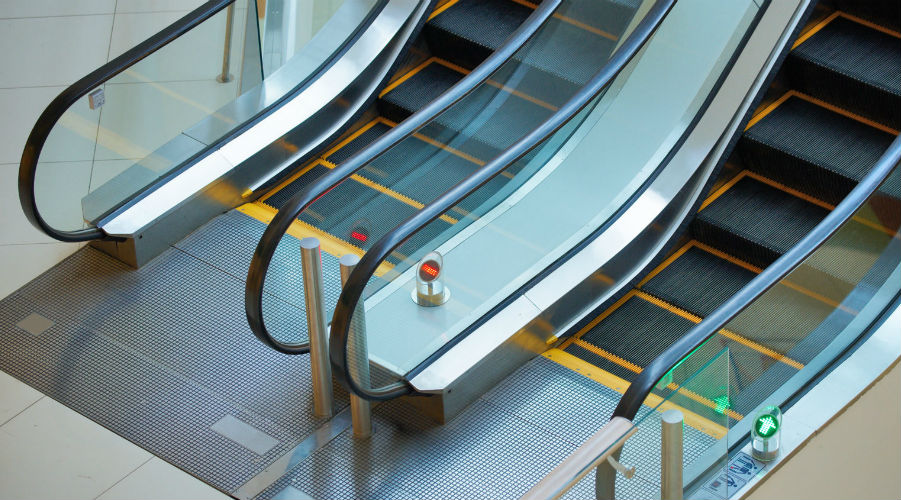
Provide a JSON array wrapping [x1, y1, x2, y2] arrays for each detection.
[[717, 167, 901, 438]]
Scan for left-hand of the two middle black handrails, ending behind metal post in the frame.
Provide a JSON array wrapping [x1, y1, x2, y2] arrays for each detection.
[[244, 0, 562, 354]]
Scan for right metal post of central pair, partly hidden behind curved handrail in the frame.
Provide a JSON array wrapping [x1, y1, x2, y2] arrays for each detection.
[[341, 254, 372, 439]]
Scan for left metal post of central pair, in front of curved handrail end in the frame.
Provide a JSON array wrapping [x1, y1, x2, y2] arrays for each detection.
[[300, 238, 334, 418]]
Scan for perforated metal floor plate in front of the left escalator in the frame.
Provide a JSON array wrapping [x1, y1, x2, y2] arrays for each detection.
[[0, 212, 346, 492]]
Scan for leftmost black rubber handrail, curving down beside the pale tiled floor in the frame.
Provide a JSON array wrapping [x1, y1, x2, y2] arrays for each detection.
[[19, 0, 235, 242]]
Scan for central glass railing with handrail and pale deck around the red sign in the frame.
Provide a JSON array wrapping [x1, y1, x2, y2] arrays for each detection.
[[331, 0, 759, 398]]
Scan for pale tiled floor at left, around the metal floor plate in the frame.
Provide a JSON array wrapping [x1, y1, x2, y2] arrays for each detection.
[[0, 0, 232, 500]]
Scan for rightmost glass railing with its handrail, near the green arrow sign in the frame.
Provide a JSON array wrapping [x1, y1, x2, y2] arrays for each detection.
[[614, 139, 901, 496]]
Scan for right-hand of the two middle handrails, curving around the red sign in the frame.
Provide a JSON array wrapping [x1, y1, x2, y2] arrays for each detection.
[[329, 0, 676, 401]]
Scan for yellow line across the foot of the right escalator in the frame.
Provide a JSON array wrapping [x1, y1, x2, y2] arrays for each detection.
[[542, 349, 743, 439]]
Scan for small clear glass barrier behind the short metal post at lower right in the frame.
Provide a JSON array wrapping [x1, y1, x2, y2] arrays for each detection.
[[563, 349, 735, 499]]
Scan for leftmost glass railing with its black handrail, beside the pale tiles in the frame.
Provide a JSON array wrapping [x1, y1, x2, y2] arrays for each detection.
[[19, 0, 383, 241]]
